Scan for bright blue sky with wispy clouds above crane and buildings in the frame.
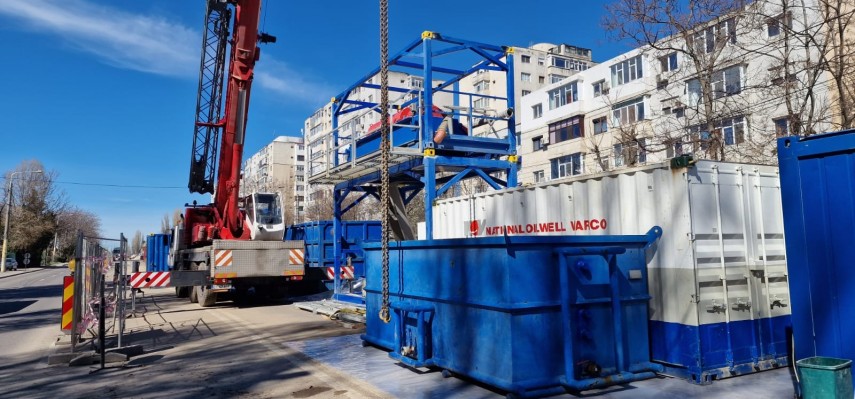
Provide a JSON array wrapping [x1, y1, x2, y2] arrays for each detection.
[[0, 0, 628, 241]]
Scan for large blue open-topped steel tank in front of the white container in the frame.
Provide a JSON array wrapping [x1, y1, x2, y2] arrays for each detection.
[[363, 227, 662, 397]]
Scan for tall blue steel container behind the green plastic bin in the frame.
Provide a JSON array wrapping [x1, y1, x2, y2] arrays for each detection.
[[778, 130, 855, 390]]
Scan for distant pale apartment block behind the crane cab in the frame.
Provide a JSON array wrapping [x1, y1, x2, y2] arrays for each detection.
[[241, 136, 306, 224]]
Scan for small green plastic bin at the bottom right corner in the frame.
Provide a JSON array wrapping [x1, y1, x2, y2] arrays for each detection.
[[796, 356, 853, 399]]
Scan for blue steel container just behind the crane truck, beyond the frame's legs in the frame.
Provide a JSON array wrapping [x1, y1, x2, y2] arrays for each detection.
[[285, 220, 382, 278]]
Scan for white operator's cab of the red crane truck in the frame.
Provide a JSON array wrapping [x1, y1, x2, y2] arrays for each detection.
[[243, 193, 285, 241]]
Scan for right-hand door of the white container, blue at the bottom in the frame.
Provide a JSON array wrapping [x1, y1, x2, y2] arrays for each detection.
[[748, 169, 790, 360]]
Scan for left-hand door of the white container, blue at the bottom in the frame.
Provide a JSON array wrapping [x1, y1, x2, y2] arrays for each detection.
[[689, 163, 757, 370]]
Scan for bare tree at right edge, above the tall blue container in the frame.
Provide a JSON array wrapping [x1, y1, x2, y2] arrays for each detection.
[[750, 0, 855, 135]]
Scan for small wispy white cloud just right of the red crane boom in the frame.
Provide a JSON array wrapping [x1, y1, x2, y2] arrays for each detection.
[[254, 57, 338, 106]]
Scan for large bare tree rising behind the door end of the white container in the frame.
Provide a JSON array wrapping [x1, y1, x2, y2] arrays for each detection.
[[604, 0, 784, 164]]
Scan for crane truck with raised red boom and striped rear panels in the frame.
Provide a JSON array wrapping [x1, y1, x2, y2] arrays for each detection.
[[169, 0, 305, 307]]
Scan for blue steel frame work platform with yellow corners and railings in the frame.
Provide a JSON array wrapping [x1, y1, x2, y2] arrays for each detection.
[[308, 32, 519, 299]]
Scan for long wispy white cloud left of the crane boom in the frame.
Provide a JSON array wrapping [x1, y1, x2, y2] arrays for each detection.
[[0, 0, 201, 77]]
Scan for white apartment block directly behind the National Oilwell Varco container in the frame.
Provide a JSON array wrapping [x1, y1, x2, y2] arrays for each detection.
[[517, 3, 830, 184]]
